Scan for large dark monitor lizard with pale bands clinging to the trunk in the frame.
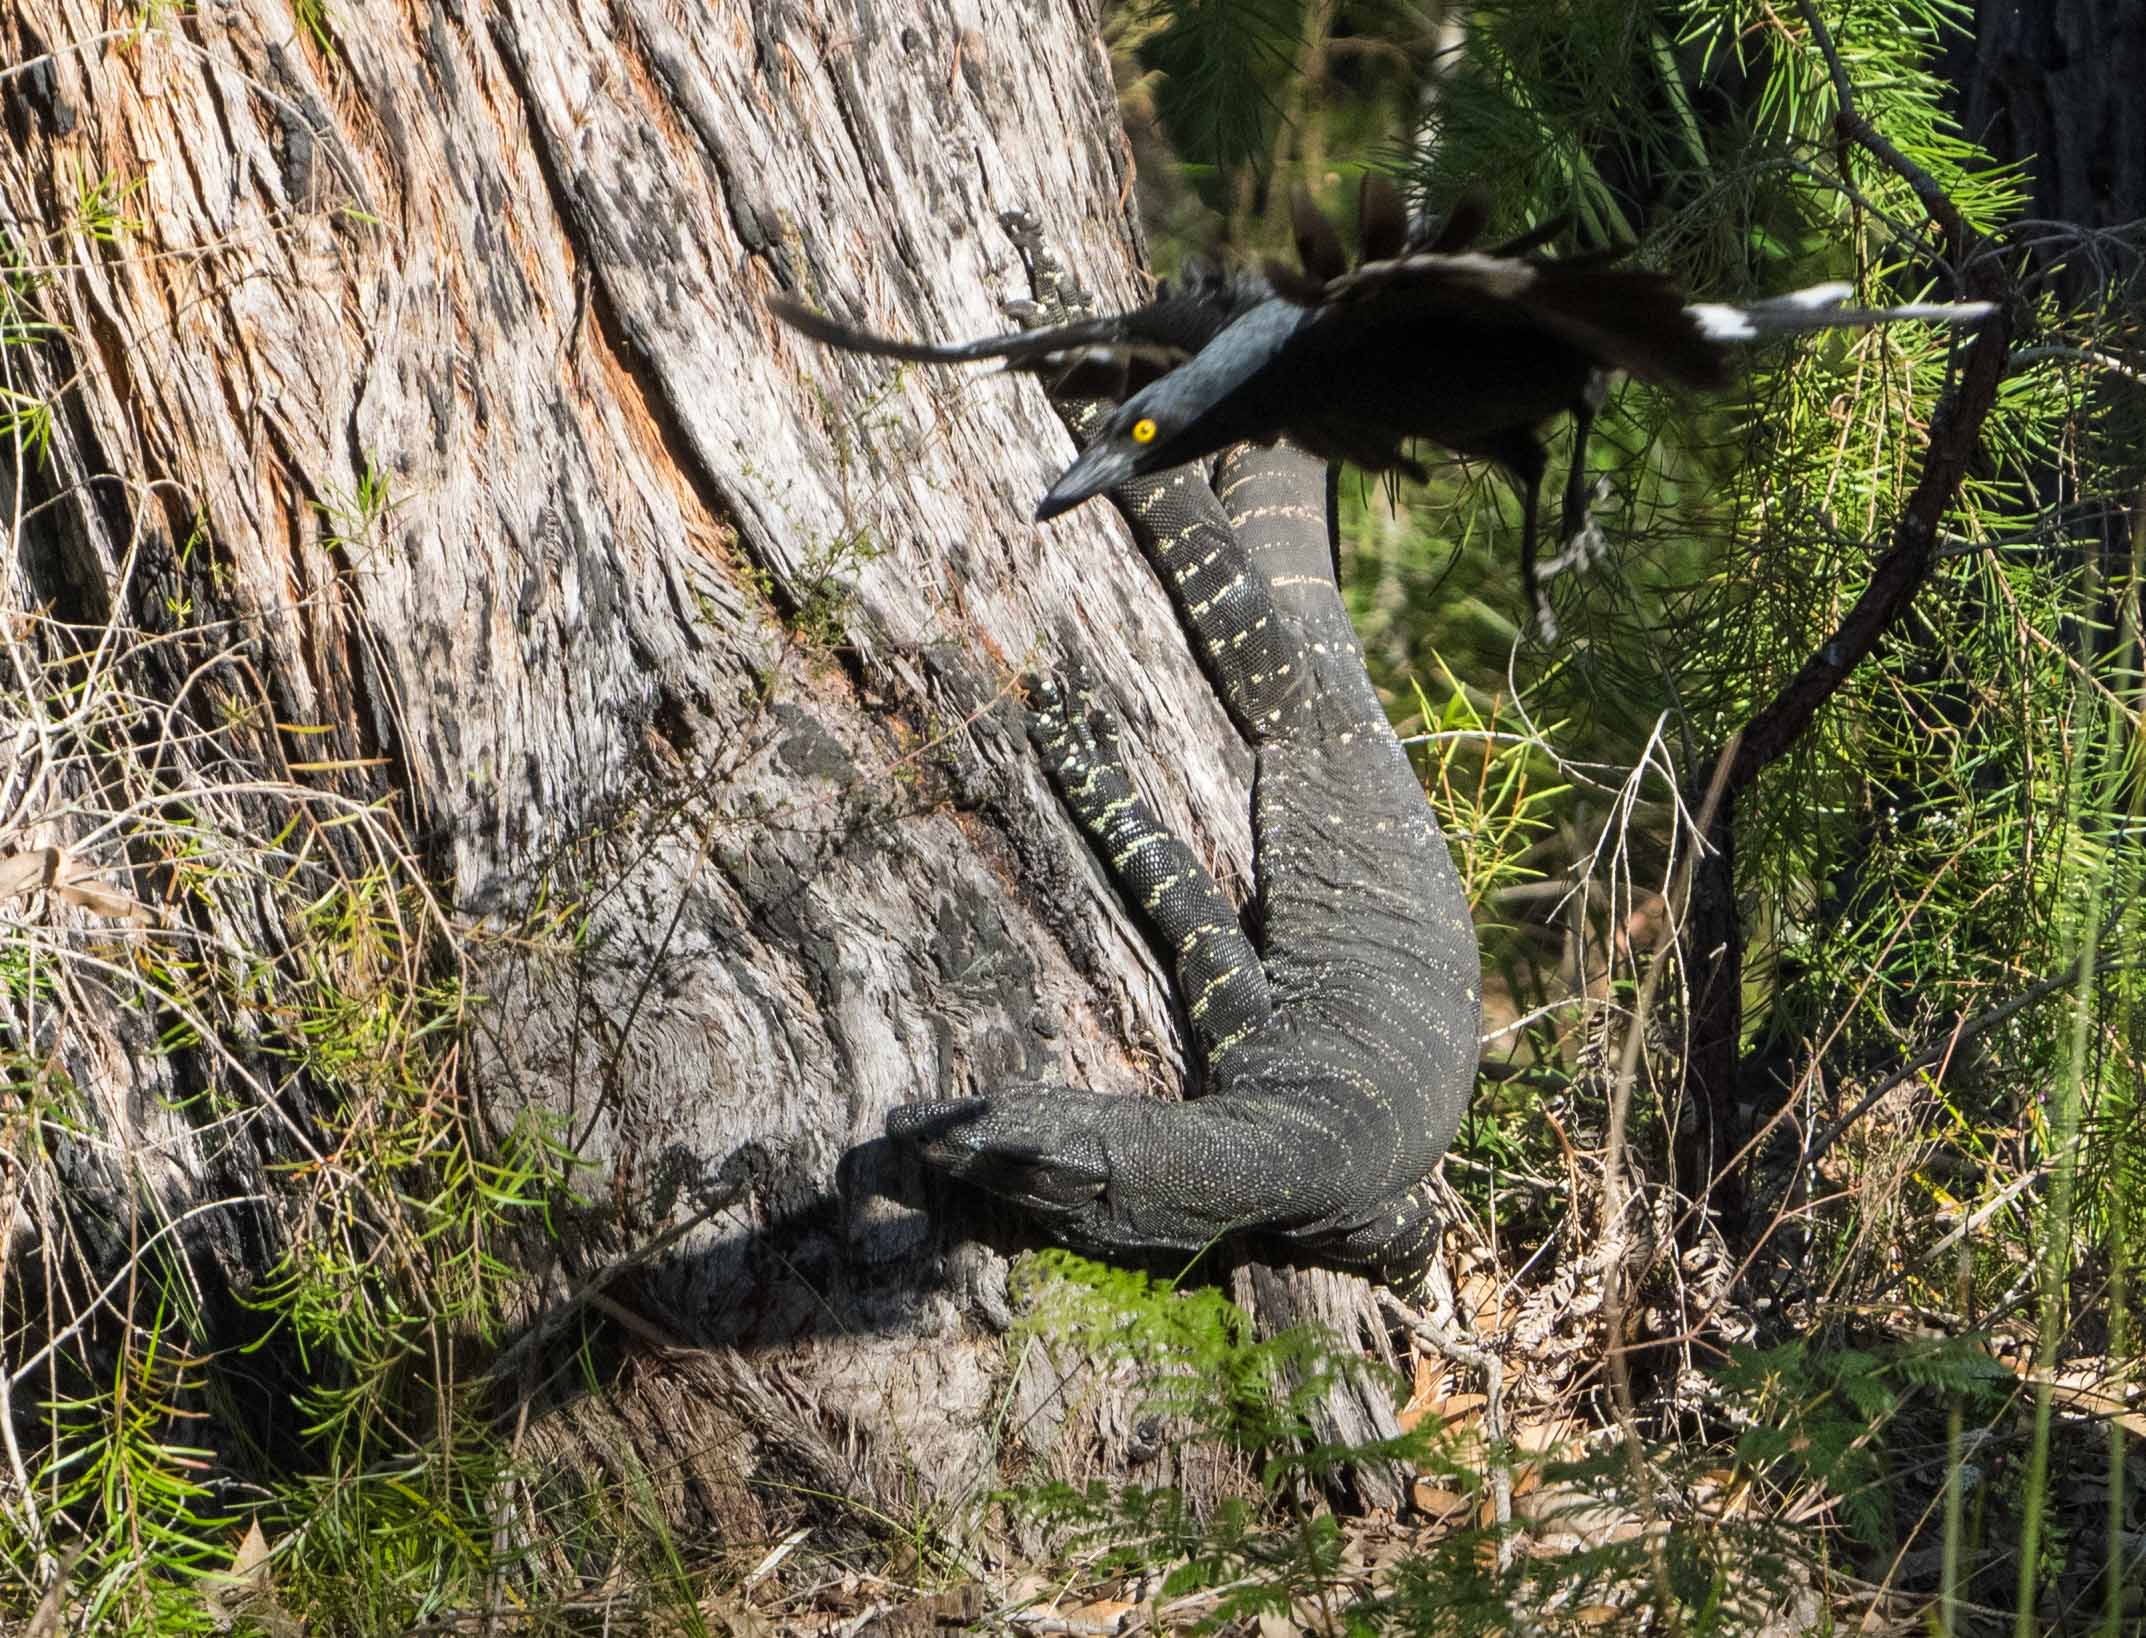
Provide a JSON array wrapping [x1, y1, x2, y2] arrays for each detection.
[[888, 225, 1479, 1288]]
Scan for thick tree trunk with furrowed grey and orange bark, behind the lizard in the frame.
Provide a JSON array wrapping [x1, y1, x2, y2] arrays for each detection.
[[0, 0, 1416, 1562]]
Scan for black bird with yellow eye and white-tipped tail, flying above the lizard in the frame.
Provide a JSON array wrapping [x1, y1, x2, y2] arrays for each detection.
[[768, 176, 1989, 642]]
